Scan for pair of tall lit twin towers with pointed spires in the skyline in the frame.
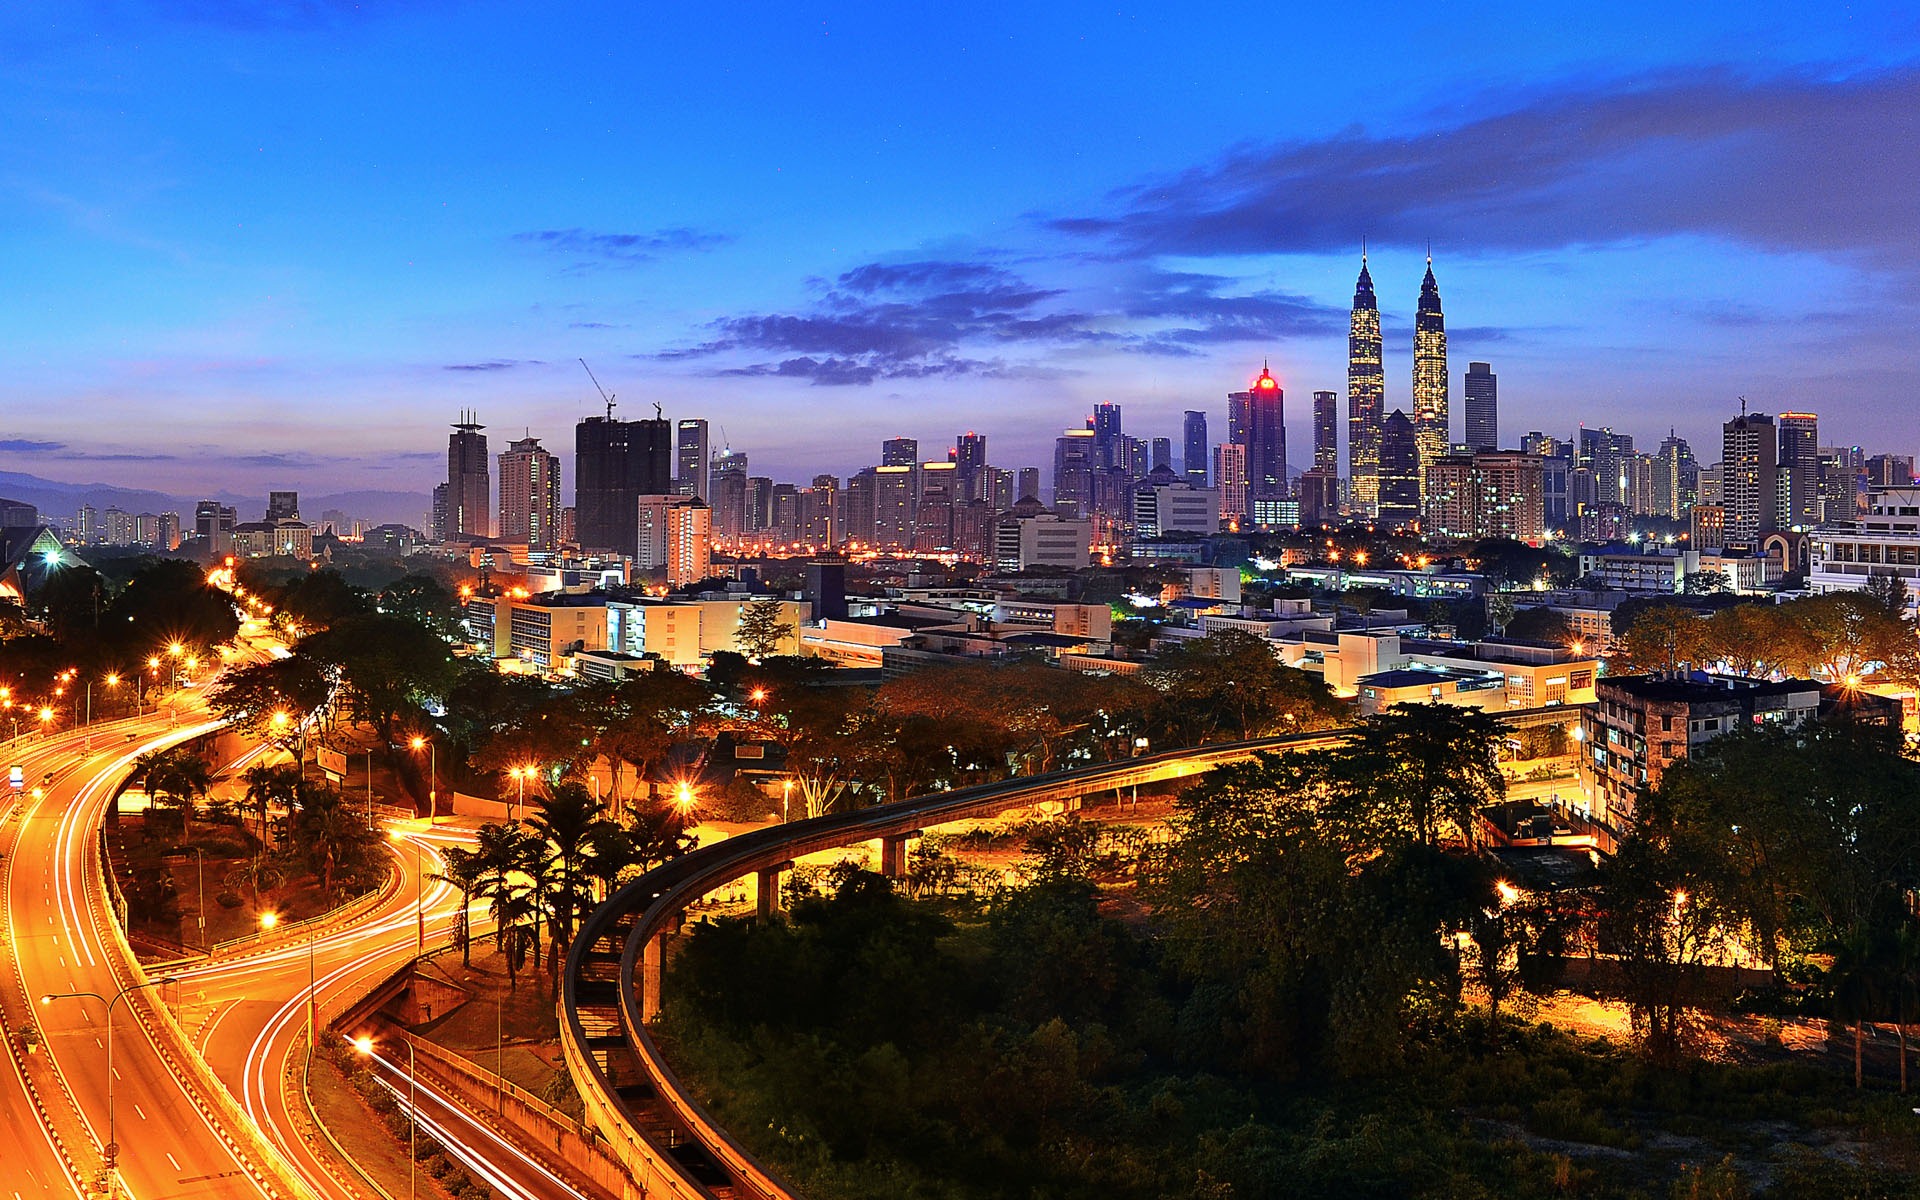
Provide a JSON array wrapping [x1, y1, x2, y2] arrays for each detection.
[[1346, 250, 1450, 516]]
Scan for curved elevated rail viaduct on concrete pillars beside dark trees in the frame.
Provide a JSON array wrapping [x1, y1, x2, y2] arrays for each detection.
[[561, 707, 1580, 1200]]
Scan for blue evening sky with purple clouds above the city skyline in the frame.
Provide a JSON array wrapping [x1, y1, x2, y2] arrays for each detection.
[[0, 0, 1920, 493]]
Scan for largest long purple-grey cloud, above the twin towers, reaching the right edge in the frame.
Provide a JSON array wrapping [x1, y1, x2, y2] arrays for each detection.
[[1046, 67, 1920, 263]]
